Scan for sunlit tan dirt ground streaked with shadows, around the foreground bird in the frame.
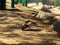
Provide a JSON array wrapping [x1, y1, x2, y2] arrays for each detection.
[[0, 2, 60, 45]]
